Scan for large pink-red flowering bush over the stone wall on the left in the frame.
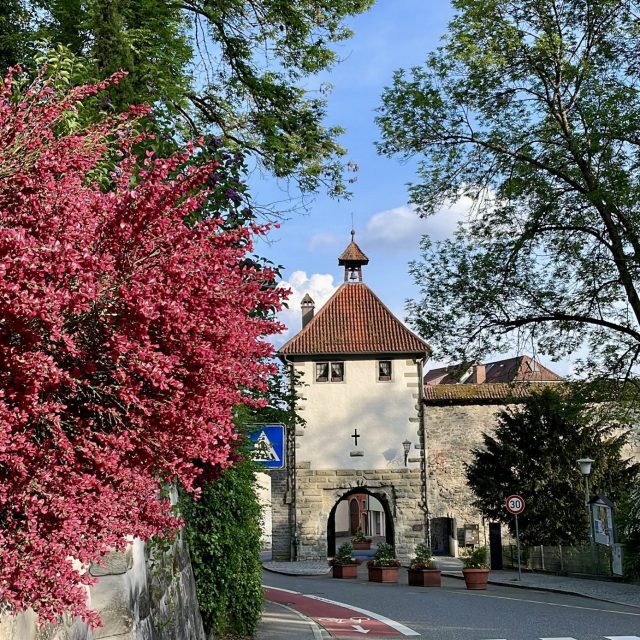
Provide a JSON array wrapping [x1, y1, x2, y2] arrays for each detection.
[[0, 73, 283, 624]]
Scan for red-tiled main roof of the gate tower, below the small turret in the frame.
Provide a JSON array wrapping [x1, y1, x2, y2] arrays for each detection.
[[279, 282, 431, 355]]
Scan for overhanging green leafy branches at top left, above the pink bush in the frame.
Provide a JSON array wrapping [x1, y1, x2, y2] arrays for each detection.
[[6, 0, 373, 195]]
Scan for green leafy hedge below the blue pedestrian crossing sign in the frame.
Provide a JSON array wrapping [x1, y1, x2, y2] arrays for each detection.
[[180, 461, 263, 636]]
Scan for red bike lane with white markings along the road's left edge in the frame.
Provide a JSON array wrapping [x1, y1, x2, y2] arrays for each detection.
[[264, 587, 418, 638]]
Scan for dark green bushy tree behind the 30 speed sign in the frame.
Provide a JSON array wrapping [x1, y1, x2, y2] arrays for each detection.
[[466, 388, 640, 545]]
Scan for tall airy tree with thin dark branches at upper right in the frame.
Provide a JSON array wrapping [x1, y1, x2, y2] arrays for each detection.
[[379, 0, 640, 375]]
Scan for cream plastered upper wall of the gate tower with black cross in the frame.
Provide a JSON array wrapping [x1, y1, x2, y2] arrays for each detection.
[[295, 357, 418, 469]]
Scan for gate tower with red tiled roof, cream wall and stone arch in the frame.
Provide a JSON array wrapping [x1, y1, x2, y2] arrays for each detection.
[[271, 232, 430, 560]]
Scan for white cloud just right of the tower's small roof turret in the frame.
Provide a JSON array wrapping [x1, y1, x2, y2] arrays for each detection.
[[362, 197, 471, 250]]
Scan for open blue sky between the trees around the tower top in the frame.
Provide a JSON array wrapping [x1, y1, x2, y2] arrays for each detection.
[[251, 0, 567, 373]]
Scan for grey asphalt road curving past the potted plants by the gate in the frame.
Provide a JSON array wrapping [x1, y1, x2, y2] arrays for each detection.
[[263, 572, 640, 640]]
